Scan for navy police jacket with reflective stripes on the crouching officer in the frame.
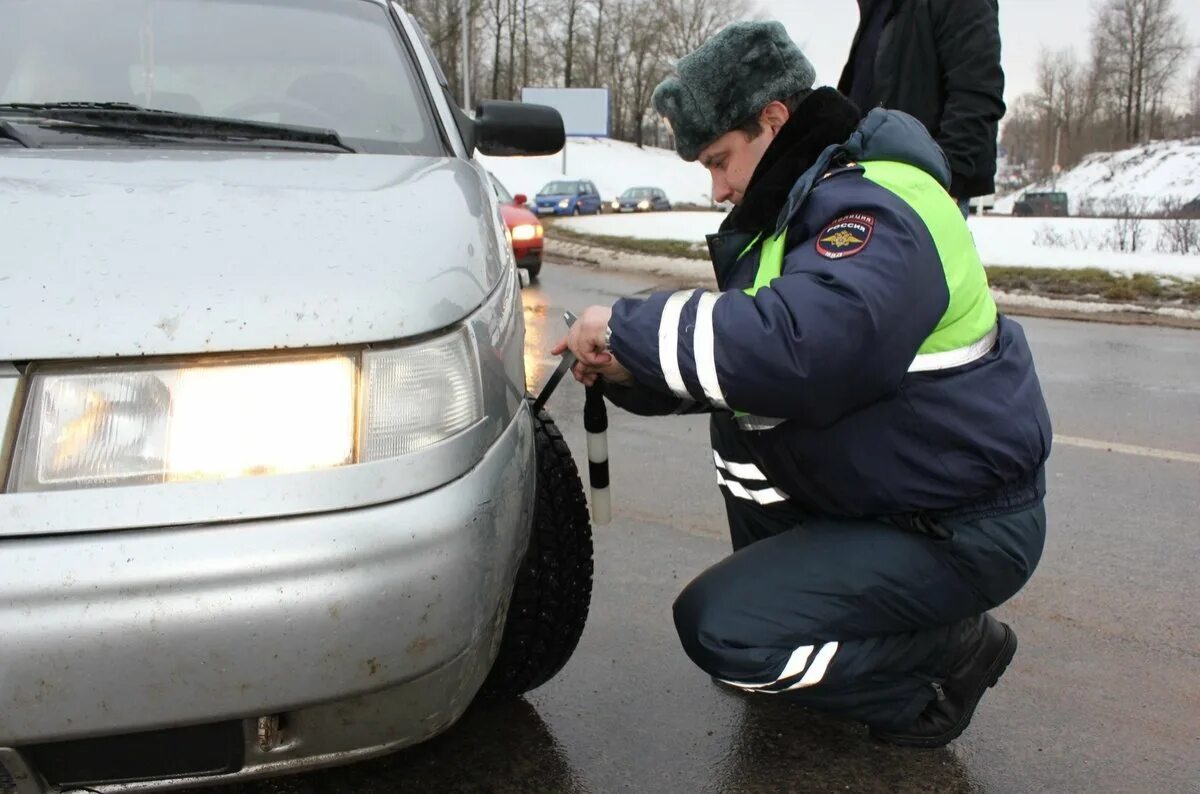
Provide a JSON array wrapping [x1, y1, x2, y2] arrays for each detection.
[[607, 89, 1050, 516]]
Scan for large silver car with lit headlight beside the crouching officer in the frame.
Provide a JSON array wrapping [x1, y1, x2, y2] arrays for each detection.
[[0, 0, 592, 794]]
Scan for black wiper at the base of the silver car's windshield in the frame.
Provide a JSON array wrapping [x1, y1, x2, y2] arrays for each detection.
[[0, 102, 355, 152]]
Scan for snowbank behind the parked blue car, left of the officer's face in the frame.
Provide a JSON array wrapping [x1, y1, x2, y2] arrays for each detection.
[[476, 138, 712, 205]]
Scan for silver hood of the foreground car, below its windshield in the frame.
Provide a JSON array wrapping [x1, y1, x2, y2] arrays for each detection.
[[0, 149, 505, 361]]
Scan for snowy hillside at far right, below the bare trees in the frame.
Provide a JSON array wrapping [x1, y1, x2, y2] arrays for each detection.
[[995, 138, 1200, 215]]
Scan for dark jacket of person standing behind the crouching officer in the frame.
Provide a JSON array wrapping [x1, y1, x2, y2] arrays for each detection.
[[838, 0, 1004, 199]]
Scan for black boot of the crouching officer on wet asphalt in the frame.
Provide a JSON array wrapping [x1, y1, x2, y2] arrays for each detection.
[[871, 614, 1016, 747]]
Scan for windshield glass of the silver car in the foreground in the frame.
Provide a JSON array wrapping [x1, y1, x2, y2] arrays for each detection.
[[0, 0, 444, 155]]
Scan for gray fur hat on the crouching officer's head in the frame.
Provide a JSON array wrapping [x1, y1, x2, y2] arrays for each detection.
[[653, 22, 816, 162]]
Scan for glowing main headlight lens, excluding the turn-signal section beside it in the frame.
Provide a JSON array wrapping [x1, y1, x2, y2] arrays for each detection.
[[14, 355, 358, 491]]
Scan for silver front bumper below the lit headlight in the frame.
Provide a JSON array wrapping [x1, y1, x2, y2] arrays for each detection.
[[0, 408, 534, 793]]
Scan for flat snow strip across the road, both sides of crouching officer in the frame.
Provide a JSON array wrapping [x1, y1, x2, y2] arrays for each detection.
[[558, 212, 1200, 278]]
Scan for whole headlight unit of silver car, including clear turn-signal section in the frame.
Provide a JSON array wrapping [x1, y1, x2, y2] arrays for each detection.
[[8, 330, 482, 492]]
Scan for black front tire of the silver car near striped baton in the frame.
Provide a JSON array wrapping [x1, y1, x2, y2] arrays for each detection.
[[482, 411, 592, 697]]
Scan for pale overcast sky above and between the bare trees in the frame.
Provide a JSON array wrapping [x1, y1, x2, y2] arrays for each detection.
[[758, 0, 1200, 104]]
